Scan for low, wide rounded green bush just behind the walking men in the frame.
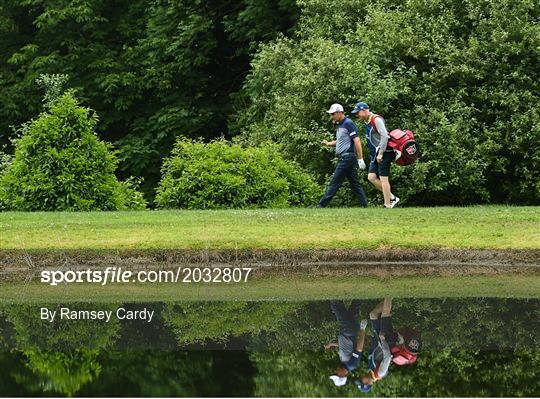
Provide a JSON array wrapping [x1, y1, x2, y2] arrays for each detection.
[[156, 138, 321, 209]]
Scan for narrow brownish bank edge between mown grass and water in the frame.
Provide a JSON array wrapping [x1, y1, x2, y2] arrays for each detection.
[[0, 249, 540, 270]]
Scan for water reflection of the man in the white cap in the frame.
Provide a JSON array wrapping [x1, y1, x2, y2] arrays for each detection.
[[324, 299, 367, 387]]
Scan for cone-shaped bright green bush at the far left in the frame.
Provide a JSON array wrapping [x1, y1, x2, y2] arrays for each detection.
[[0, 92, 146, 211]]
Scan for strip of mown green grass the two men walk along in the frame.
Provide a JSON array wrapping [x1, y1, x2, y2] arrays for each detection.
[[0, 206, 540, 250]]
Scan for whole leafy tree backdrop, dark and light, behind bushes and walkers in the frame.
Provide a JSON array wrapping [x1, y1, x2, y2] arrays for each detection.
[[0, 0, 540, 205]]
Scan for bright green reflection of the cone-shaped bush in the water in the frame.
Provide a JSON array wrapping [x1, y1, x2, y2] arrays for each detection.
[[5, 304, 120, 396]]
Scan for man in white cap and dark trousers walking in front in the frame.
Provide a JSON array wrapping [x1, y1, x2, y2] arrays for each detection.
[[317, 104, 367, 208]]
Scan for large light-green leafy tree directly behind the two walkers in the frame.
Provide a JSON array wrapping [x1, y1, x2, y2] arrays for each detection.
[[236, 0, 540, 204]]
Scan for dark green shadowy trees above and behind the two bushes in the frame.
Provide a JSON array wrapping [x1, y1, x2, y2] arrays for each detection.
[[0, 0, 298, 199]]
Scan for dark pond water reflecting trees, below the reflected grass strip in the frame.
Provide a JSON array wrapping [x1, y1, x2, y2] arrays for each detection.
[[0, 298, 540, 397]]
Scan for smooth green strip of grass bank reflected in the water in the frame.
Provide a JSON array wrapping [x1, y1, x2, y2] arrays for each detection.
[[0, 274, 540, 303]]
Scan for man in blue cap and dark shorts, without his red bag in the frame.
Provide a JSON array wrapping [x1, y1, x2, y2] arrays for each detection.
[[352, 101, 399, 208]]
